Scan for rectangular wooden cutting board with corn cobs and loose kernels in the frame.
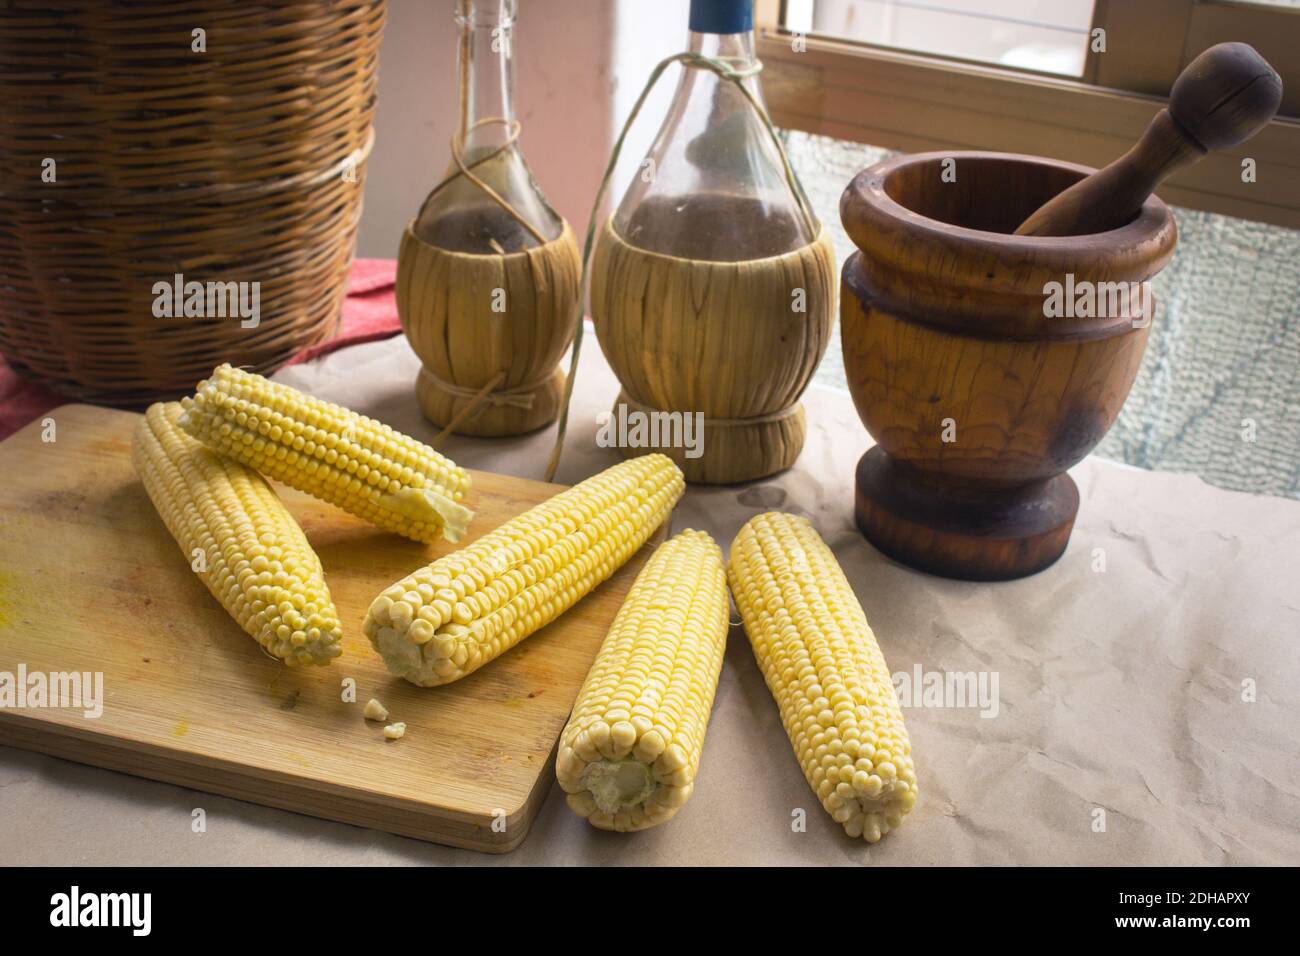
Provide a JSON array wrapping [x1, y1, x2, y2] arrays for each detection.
[[0, 405, 658, 852]]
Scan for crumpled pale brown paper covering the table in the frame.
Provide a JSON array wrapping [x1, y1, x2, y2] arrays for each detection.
[[0, 328, 1300, 865]]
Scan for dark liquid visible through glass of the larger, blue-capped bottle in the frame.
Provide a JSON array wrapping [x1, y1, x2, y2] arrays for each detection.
[[620, 194, 815, 263]]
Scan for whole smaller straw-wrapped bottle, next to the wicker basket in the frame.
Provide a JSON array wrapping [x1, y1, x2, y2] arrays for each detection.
[[397, 0, 582, 437]]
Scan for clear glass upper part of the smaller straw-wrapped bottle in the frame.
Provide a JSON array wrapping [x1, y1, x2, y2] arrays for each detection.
[[413, 0, 563, 255]]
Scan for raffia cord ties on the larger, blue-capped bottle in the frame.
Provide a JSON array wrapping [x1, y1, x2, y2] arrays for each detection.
[[546, 52, 818, 481]]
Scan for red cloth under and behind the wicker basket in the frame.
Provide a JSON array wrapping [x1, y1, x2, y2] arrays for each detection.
[[0, 259, 402, 440]]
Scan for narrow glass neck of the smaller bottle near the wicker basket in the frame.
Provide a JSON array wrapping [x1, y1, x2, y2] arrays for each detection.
[[456, 0, 516, 161]]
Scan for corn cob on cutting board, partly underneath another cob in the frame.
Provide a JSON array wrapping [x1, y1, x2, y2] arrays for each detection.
[[131, 402, 343, 665]]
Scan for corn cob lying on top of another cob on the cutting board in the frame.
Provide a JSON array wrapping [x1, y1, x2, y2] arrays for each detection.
[[181, 365, 473, 544]]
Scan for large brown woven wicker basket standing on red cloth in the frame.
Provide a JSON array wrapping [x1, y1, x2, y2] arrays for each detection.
[[0, 0, 385, 405]]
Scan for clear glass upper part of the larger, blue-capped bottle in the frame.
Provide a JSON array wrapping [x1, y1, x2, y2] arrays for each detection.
[[614, 0, 818, 261]]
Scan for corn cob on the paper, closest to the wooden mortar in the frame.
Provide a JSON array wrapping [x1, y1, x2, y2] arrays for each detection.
[[728, 512, 917, 843]]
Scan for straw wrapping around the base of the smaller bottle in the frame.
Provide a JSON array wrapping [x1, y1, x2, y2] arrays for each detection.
[[397, 222, 582, 437]]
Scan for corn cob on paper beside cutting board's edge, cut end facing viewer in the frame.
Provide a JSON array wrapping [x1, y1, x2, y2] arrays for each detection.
[[555, 531, 731, 831]]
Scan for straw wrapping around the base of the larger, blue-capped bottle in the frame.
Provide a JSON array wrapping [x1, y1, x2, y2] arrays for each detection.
[[590, 219, 835, 484]]
